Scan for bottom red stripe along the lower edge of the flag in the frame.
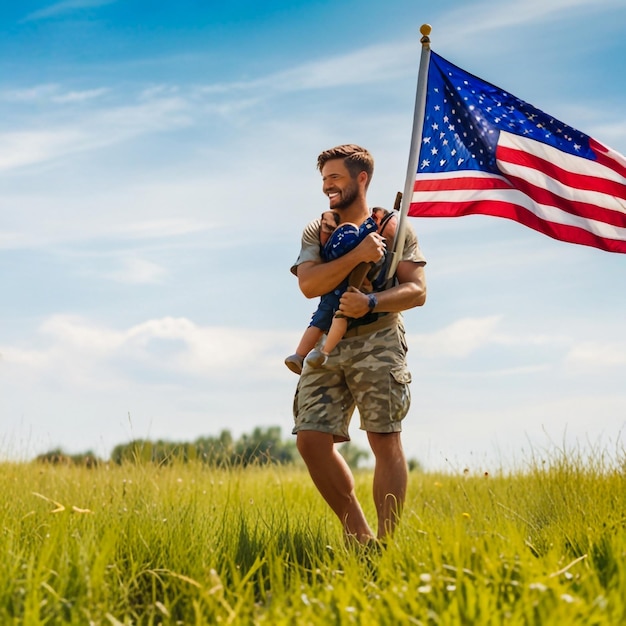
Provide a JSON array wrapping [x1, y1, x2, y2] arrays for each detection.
[[408, 200, 626, 253]]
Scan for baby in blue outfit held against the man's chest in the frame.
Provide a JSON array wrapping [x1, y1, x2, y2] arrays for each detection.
[[285, 207, 397, 374]]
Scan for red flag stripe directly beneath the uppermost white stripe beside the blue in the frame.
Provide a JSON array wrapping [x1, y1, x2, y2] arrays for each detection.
[[496, 144, 626, 200]]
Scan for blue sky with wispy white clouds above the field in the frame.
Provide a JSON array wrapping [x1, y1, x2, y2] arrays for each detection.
[[0, 0, 626, 471]]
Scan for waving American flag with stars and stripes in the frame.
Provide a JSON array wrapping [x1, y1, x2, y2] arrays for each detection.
[[408, 52, 626, 253]]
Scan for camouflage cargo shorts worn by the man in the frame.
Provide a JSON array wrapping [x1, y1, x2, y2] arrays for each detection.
[[293, 321, 411, 442]]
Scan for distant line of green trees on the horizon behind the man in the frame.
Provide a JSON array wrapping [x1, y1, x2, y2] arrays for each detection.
[[36, 426, 421, 470]]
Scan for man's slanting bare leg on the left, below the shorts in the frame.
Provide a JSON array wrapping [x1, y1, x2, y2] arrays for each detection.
[[297, 430, 374, 543]]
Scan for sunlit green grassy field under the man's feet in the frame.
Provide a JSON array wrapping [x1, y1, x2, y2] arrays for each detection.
[[0, 455, 626, 626]]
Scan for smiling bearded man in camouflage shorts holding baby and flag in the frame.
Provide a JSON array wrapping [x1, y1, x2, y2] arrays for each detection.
[[291, 144, 426, 543]]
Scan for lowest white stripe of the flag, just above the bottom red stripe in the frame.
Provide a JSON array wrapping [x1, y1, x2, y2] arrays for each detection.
[[411, 184, 626, 241]]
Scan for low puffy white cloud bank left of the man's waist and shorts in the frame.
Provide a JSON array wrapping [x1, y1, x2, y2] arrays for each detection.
[[0, 315, 296, 390]]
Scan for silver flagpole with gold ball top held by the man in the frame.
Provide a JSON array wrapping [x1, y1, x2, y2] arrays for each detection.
[[387, 24, 432, 281]]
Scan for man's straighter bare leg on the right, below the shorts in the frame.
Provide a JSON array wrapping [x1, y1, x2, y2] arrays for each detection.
[[367, 432, 408, 539]]
